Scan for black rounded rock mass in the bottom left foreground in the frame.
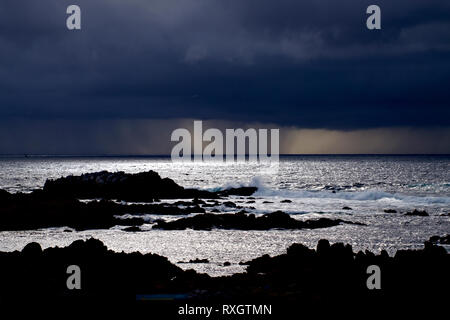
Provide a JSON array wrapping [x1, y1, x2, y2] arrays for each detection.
[[0, 239, 197, 304]]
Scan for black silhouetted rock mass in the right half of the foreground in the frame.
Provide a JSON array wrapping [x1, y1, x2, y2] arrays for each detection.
[[237, 240, 450, 307]]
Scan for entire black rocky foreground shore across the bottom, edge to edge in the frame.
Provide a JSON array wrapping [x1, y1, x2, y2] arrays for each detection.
[[0, 239, 450, 316]]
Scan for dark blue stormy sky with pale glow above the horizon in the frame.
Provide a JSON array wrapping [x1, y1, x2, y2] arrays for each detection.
[[0, 0, 450, 154]]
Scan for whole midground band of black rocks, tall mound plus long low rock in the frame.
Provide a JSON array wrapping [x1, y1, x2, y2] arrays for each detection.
[[0, 171, 362, 232]]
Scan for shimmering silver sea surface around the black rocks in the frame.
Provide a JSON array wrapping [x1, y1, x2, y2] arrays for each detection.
[[0, 156, 450, 275]]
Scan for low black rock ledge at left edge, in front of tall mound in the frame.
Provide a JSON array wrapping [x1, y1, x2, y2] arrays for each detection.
[[0, 190, 209, 231]]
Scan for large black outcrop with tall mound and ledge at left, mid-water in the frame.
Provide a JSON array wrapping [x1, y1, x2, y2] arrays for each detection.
[[0, 171, 256, 231]]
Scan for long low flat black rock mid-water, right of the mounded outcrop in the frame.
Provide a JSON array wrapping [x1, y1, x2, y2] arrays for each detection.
[[153, 211, 364, 230]]
